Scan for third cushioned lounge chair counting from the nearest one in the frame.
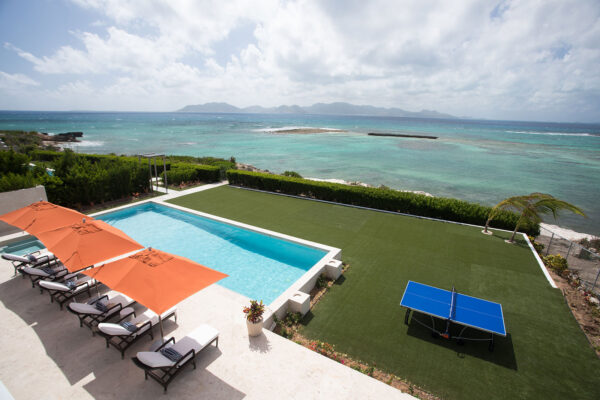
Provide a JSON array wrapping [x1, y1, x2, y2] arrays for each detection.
[[67, 291, 135, 334]]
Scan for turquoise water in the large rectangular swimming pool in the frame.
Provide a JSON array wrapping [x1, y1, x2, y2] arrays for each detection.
[[96, 203, 327, 304]]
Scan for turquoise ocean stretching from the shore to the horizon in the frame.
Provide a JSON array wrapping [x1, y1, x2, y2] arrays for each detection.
[[0, 111, 600, 235]]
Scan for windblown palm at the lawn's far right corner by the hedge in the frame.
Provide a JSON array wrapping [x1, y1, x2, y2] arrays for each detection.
[[484, 193, 586, 243]]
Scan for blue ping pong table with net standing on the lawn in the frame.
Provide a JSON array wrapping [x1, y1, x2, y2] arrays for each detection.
[[400, 281, 506, 351]]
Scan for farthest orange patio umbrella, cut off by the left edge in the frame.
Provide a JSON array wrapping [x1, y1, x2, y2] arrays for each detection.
[[0, 201, 92, 236]]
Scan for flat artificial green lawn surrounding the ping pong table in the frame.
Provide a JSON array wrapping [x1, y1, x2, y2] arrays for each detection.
[[171, 187, 600, 399]]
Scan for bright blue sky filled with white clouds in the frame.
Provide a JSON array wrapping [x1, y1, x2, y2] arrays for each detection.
[[0, 0, 600, 122]]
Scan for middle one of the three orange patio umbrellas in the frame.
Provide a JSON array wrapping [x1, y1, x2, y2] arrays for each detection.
[[36, 218, 144, 272]]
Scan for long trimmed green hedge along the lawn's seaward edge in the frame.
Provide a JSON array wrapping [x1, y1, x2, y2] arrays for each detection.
[[227, 170, 539, 235]]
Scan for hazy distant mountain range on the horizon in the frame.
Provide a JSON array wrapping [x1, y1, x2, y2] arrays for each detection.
[[177, 103, 457, 119]]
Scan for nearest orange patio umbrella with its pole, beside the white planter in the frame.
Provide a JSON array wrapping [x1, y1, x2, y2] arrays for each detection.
[[84, 248, 228, 336]]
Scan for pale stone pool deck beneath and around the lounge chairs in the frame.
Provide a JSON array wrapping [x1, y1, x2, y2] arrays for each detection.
[[0, 255, 413, 399]]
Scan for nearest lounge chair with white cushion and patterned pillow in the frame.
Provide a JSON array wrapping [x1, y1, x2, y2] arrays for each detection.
[[132, 324, 219, 393]]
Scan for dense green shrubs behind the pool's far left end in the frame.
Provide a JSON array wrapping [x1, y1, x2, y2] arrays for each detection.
[[0, 131, 229, 208]]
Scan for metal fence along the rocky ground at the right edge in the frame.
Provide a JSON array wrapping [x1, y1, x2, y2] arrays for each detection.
[[535, 228, 600, 294]]
